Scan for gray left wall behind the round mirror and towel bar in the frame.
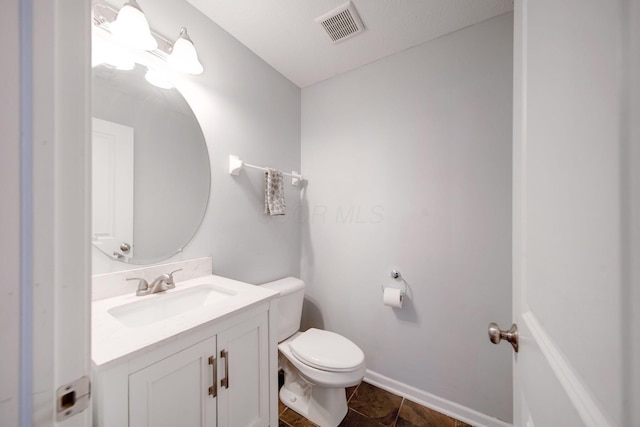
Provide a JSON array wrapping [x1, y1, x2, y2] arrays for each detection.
[[93, 0, 300, 283]]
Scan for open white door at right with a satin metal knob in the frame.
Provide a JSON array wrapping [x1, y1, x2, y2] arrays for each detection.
[[508, 0, 637, 427]]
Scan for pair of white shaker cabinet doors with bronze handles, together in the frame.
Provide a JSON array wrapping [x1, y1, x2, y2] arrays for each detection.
[[129, 313, 269, 427]]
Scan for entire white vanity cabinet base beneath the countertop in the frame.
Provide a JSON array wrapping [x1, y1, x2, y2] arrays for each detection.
[[92, 276, 278, 427]]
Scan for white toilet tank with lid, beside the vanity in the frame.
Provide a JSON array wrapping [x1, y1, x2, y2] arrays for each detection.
[[261, 277, 304, 342]]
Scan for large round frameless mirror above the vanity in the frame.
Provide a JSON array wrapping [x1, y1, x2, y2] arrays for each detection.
[[92, 64, 211, 264]]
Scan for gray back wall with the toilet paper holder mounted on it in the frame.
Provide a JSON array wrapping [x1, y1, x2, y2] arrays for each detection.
[[301, 14, 513, 421]]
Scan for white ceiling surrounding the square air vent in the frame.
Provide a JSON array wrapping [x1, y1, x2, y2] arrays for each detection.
[[187, 0, 513, 87]]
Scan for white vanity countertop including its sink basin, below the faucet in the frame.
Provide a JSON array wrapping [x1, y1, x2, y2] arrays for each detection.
[[91, 276, 278, 366]]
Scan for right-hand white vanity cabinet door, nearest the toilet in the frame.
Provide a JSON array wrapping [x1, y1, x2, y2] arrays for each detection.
[[218, 313, 269, 427]]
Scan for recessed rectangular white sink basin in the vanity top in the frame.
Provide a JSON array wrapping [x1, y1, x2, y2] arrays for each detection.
[[107, 284, 236, 328]]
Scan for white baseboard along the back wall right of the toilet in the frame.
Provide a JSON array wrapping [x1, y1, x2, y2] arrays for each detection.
[[364, 369, 512, 427]]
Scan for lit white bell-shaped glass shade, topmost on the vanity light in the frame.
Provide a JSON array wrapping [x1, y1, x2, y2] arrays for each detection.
[[109, 0, 158, 50]]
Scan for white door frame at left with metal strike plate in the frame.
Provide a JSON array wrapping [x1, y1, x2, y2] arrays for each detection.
[[27, 0, 91, 427]]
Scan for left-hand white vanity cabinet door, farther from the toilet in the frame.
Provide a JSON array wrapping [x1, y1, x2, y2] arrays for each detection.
[[129, 338, 216, 427]]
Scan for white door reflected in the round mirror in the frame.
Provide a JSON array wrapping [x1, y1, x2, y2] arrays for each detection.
[[91, 117, 134, 258]]
